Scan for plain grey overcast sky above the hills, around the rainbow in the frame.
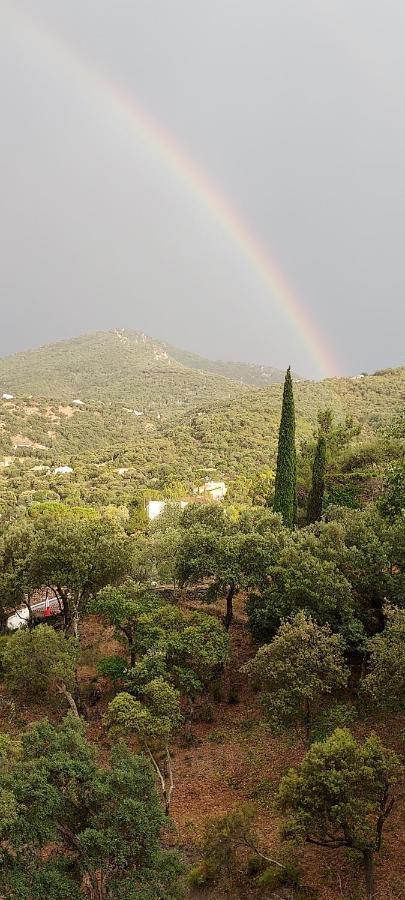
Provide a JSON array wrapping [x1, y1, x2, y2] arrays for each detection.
[[0, 0, 405, 376]]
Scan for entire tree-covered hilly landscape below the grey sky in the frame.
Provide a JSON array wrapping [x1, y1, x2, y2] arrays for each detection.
[[0, 332, 405, 900]]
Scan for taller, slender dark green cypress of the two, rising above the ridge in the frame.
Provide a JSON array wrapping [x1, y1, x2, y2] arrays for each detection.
[[274, 366, 297, 528]]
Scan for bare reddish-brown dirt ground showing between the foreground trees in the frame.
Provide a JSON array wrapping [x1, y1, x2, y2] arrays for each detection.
[[0, 600, 405, 900]]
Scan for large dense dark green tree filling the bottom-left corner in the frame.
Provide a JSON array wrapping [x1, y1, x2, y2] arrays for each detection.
[[0, 717, 181, 900]]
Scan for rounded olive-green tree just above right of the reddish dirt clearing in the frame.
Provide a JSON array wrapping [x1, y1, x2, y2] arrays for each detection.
[[244, 611, 349, 737]]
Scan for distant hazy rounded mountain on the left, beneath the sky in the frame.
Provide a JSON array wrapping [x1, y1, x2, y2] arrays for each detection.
[[0, 329, 290, 411]]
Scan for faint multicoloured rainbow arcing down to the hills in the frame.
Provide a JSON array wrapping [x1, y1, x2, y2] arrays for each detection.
[[7, 6, 339, 376]]
